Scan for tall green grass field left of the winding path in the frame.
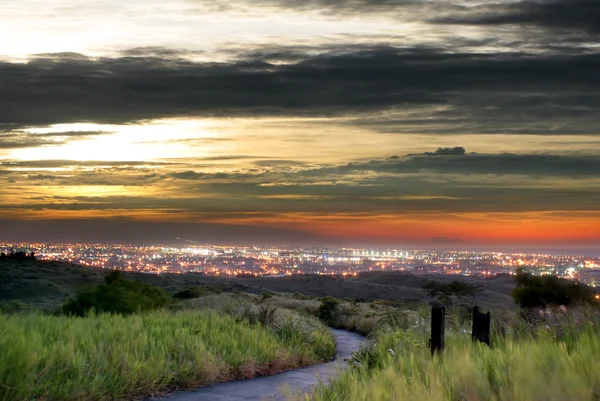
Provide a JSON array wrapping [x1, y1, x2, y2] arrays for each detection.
[[0, 311, 335, 400]]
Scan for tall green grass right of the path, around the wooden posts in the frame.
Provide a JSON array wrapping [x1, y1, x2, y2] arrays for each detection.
[[307, 312, 600, 401]]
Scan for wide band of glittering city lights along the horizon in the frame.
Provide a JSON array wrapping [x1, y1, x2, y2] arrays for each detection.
[[0, 243, 600, 286]]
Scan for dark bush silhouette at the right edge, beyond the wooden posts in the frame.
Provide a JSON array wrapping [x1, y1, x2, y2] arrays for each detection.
[[512, 270, 596, 308]]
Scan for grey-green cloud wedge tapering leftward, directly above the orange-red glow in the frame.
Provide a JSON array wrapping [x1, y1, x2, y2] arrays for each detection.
[[156, 147, 600, 211]]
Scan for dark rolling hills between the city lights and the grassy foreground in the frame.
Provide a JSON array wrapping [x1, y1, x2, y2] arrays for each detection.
[[0, 261, 514, 310]]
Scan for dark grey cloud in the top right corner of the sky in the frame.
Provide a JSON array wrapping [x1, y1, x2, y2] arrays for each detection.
[[434, 0, 600, 34]]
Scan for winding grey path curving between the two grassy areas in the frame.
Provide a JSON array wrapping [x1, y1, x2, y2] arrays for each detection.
[[151, 329, 365, 401]]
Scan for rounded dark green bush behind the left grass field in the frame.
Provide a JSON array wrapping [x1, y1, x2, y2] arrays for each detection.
[[62, 270, 170, 316]]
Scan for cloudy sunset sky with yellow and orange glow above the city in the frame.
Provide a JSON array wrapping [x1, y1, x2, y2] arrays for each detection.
[[0, 0, 600, 249]]
